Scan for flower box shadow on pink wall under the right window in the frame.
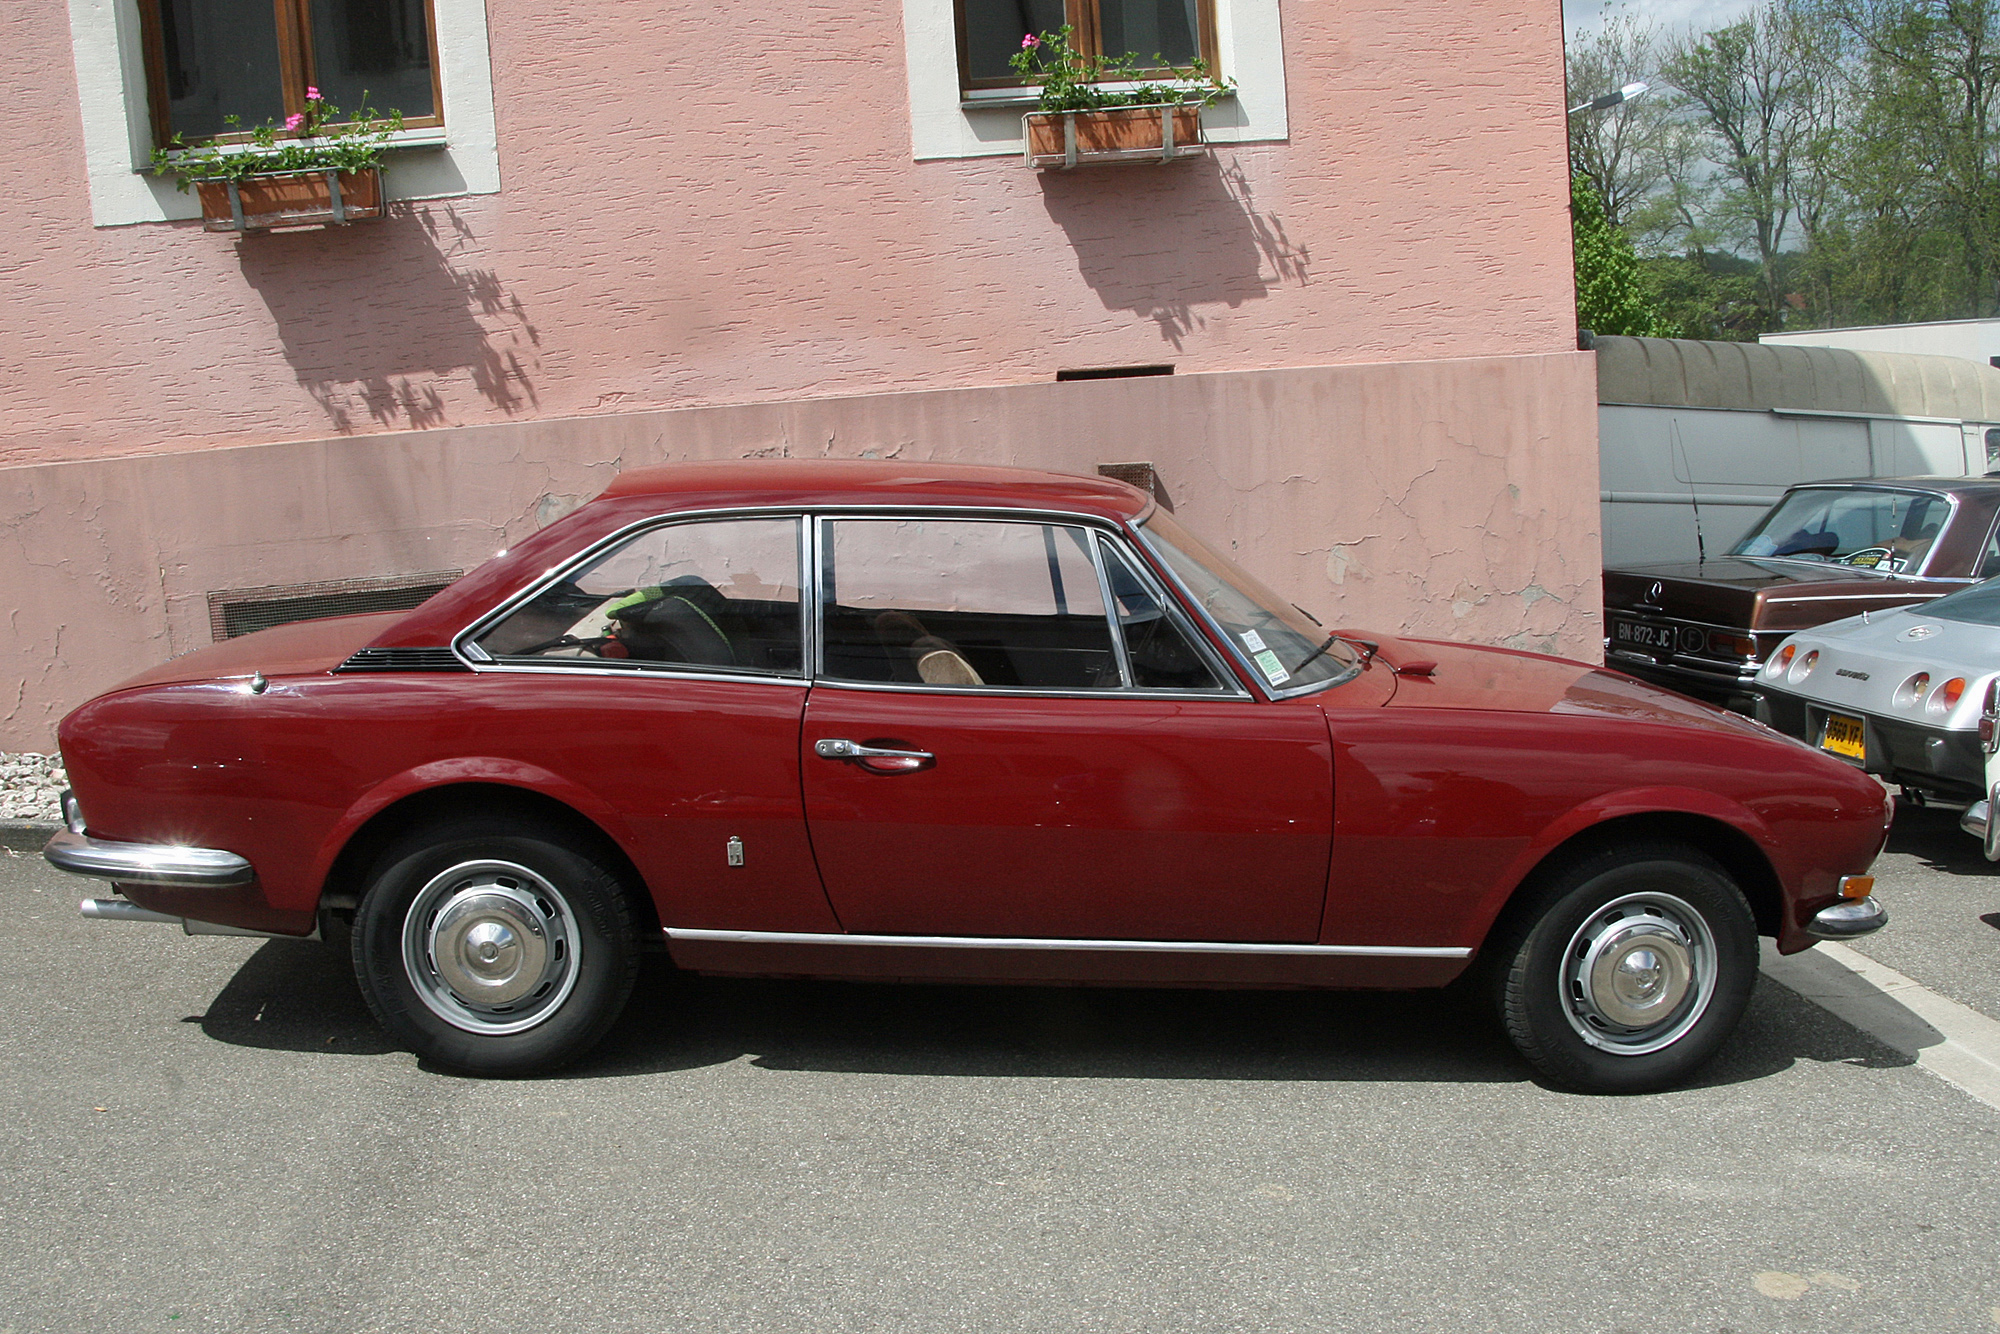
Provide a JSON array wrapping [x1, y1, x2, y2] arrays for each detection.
[[1042, 156, 1312, 350]]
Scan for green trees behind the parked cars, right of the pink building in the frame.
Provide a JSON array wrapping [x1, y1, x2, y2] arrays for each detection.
[[1568, 0, 2000, 338]]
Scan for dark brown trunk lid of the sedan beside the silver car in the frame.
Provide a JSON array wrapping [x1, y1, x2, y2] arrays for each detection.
[[1604, 556, 1964, 630]]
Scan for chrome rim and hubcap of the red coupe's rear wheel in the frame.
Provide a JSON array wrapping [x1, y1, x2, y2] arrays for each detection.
[[402, 862, 578, 1036]]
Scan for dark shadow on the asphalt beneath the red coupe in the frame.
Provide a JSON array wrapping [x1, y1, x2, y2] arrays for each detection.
[[188, 940, 1910, 1088]]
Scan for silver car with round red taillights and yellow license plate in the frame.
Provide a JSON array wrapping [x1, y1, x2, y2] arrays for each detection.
[[1758, 580, 2000, 820]]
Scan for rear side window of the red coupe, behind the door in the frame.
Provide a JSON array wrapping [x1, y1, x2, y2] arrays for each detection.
[[474, 518, 802, 676]]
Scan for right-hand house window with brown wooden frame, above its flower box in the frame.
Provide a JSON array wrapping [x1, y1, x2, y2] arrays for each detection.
[[958, 0, 1216, 88]]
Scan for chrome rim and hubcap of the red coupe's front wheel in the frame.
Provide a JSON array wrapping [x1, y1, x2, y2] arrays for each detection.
[[1562, 894, 1716, 1056]]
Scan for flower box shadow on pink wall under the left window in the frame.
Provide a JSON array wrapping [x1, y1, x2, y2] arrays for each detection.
[[236, 204, 540, 430]]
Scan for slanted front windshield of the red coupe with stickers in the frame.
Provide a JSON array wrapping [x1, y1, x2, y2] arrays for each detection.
[[1140, 510, 1362, 690]]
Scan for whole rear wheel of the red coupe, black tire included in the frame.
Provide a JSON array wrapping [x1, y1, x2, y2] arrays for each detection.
[[354, 816, 638, 1076]]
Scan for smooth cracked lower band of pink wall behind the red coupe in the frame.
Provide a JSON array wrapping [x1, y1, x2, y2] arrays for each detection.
[[0, 352, 1600, 750]]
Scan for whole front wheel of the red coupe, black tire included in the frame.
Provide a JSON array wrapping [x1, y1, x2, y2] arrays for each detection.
[[1488, 842, 1758, 1094]]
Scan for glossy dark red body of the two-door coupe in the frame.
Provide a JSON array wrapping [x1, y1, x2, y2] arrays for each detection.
[[50, 464, 1886, 986]]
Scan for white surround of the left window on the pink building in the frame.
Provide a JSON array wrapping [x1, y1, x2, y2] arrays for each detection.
[[70, 0, 500, 226]]
